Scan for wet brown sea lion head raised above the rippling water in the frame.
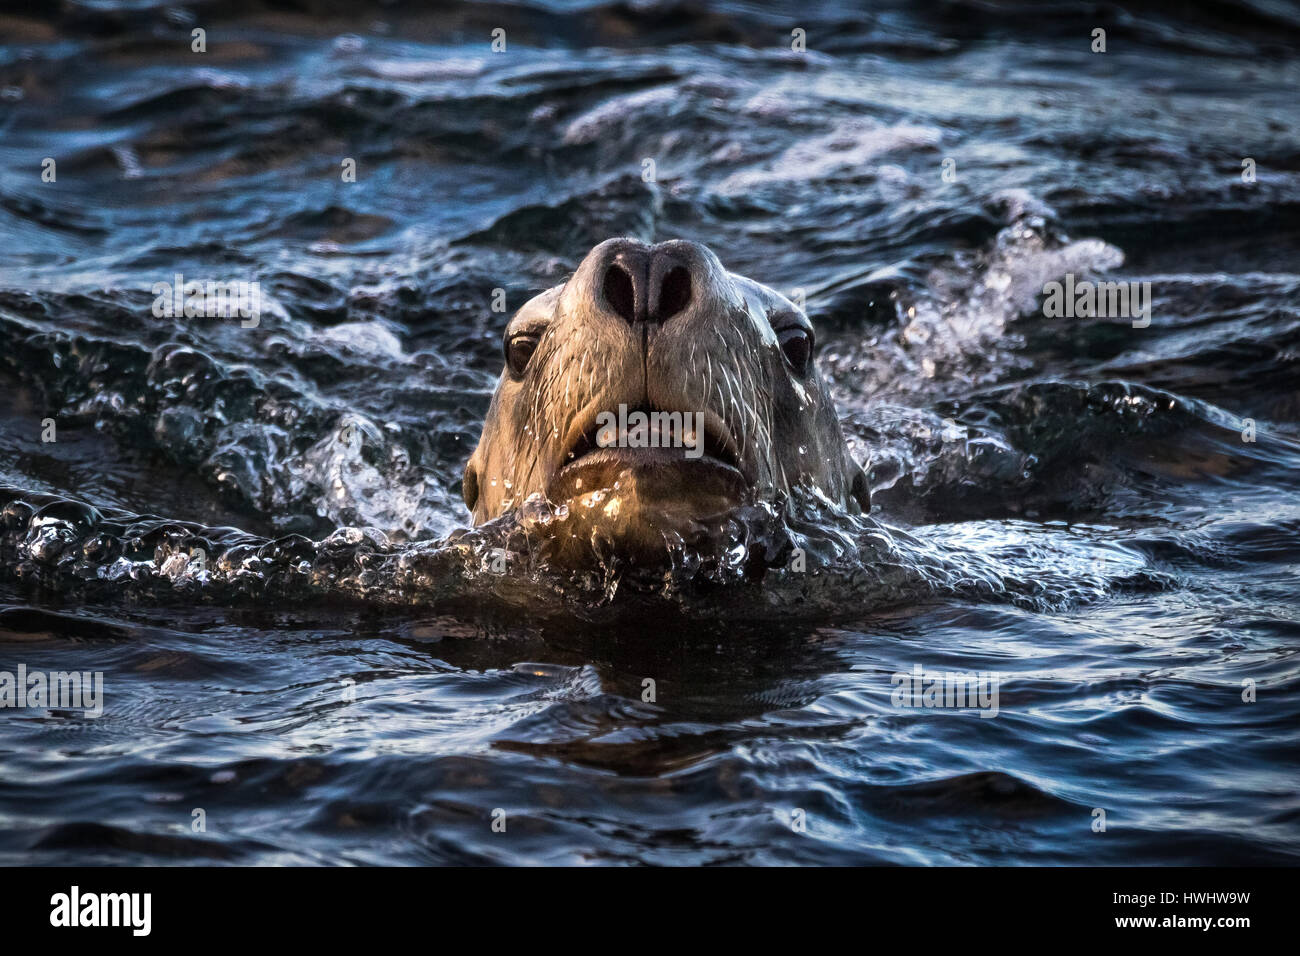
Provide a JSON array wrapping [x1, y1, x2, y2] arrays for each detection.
[[463, 238, 870, 559]]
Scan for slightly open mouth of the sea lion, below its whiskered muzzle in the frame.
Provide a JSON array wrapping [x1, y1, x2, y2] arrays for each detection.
[[551, 406, 751, 499]]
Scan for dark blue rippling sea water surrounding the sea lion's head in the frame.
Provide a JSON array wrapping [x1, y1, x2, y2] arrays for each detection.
[[0, 0, 1300, 864]]
